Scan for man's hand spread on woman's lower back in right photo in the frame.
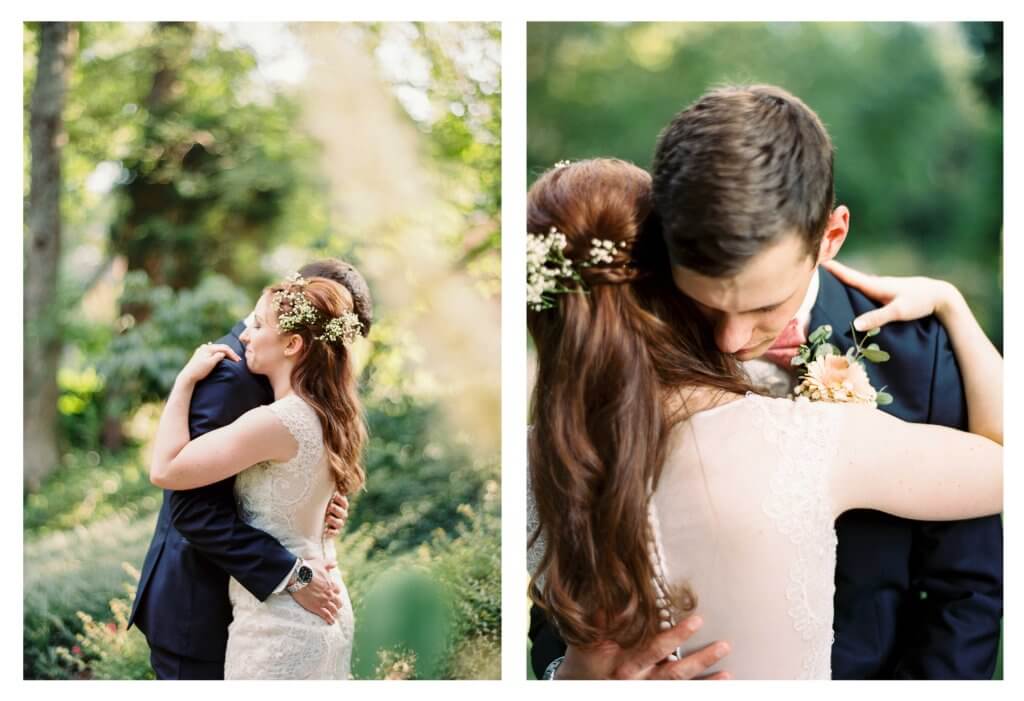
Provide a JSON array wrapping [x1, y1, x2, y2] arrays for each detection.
[[555, 616, 730, 680]]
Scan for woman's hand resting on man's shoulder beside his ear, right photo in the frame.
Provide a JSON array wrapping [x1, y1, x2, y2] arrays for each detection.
[[822, 260, 959, 332]]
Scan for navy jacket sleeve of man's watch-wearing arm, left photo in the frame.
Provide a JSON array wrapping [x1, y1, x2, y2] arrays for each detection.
[[170, 361, 296, 601]]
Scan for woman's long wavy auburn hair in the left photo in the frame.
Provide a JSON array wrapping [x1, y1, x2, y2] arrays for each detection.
[[265, 277, 367, 494]]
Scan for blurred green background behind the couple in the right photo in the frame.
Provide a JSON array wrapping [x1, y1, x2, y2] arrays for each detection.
[[526, 23, 1002, 349]]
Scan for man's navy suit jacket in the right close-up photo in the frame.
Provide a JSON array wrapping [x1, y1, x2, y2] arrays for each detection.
[[529, 268, 1002, 680]]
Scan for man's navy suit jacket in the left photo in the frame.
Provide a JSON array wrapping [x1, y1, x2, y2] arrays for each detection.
[[129, 321, 296, 661]]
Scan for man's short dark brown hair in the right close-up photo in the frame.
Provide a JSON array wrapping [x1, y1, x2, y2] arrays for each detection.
[[651, 85, 835, 277]]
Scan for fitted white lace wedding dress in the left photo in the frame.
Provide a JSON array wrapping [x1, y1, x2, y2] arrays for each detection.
[[224, 394, 355, 680]]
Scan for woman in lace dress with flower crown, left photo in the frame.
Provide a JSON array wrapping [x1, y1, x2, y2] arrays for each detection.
[[151, 275, 366, 680]]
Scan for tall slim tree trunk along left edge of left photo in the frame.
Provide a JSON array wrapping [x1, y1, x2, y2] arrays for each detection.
[[24, 21, 78, 488]]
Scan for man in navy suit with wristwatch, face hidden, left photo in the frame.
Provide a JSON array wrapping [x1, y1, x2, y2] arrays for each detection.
[[128, 259, 373, 680]]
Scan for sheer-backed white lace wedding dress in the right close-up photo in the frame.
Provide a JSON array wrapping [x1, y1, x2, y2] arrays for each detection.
[[528, 394, 842, 680]]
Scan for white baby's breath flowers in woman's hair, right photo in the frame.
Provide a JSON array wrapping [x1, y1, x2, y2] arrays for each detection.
[[526, 226, 627, 311]]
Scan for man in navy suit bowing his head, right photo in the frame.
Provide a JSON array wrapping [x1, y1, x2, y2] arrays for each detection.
[[530, 86, 1002, 680]]
